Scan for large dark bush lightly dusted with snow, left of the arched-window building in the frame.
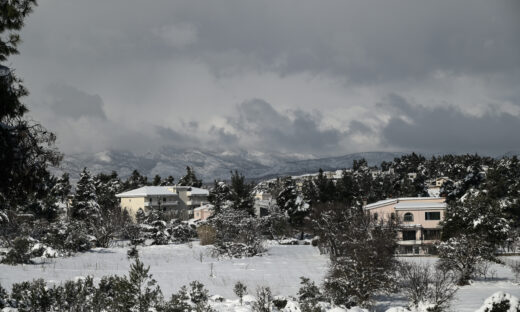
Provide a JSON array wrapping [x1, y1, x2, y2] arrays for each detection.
[[314, 204, 397, 308]]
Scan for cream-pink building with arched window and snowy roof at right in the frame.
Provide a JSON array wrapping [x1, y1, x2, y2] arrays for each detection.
[[364, 197, 446, 255]]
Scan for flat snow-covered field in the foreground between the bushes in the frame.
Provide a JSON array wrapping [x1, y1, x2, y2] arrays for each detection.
[[0, 243, 520, 312]]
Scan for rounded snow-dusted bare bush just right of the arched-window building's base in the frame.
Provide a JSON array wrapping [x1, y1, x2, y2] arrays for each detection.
[[437, 234, 499, 286]]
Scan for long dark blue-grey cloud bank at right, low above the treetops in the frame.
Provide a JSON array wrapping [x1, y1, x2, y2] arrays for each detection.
[[382, 94, 520, 153]]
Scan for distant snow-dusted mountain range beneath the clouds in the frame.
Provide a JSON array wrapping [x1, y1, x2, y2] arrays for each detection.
[[55, 147, 403, 182]]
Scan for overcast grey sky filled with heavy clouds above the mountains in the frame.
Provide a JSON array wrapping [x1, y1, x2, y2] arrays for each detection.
[[9, 0, 520, 156]]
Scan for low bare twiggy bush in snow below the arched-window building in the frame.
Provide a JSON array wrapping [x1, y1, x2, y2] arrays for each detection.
[[399, 263, 457, 312]]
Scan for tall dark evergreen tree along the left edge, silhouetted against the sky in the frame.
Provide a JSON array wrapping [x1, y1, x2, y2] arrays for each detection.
[[0, 0, 61, 222]]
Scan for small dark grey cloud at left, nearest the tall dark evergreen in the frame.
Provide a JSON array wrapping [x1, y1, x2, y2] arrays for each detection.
[[47, 84, 106, 120]]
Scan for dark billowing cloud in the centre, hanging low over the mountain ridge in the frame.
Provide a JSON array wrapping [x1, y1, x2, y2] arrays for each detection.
[[228, 99, 342, 152]]
